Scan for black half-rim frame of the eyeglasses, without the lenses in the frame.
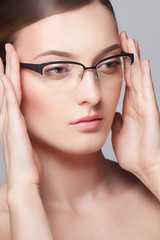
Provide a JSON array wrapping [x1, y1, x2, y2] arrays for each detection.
[[20, 52, 134, 78]]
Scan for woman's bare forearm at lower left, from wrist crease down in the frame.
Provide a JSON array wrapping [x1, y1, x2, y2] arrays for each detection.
[[8, 187, 53, 240]]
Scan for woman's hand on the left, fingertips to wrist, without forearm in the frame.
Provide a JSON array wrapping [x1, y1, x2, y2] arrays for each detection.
[[0, 44, 42, 192]]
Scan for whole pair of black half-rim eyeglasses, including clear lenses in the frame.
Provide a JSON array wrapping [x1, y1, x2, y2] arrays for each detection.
[[5, 52, 134, 91]]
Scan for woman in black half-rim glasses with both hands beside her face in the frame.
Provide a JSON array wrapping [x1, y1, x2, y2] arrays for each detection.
[[0, 0, 160, 240]]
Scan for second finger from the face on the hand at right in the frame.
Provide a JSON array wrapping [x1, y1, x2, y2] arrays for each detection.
[[127, 38, 143, 96]]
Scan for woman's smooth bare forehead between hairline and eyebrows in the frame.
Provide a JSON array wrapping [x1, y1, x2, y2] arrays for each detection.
[[16, 3, 119, 61]]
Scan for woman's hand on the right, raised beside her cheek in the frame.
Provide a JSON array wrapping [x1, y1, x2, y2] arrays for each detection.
[[112, 32, 160, 200]]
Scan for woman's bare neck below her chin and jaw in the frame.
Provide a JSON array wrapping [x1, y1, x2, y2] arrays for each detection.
[[33, 139, 107, 212]]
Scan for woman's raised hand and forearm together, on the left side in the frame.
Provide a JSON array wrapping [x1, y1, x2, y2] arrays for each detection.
[[0, 44, 53, 240]]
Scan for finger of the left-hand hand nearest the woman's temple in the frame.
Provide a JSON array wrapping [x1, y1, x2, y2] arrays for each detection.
[[7, 44, 22, 106]]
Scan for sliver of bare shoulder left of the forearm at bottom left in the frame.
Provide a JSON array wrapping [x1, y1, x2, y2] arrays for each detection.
[[0, 183, 10, 240]]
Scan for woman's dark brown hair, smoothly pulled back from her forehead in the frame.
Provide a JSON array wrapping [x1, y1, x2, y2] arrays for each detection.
[[0, 0, 115, 58]]
